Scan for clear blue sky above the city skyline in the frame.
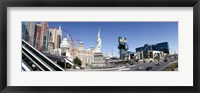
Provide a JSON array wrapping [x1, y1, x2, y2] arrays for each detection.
[[22, 22, 178, 56]]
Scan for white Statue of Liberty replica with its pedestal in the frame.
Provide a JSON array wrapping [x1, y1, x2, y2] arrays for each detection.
[[94, 28, 105, 66]]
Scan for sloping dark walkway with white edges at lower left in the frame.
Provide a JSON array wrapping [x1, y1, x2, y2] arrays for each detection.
[[22, 39, 80, 71]]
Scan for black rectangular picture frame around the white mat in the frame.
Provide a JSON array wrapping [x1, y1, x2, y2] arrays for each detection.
[[0, 0, 200, 93]]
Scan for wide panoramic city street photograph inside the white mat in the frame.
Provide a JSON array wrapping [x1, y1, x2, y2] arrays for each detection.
[[21, 21, 178, 72]]
